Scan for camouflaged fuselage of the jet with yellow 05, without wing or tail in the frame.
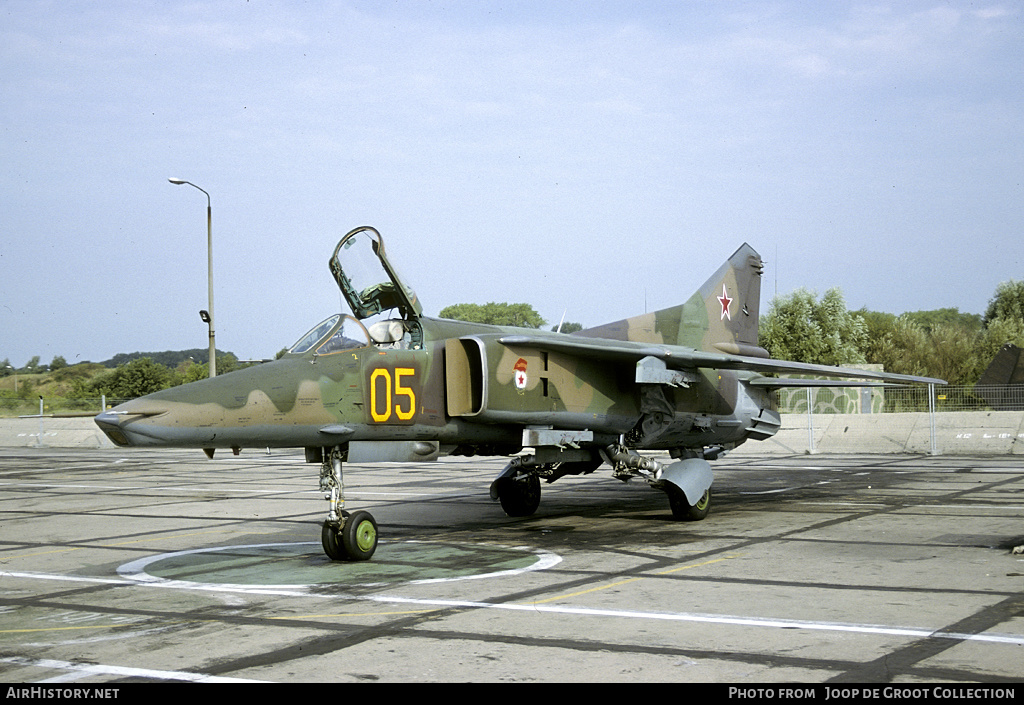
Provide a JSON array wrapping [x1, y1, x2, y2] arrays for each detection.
[[96, 316, 772, 453]]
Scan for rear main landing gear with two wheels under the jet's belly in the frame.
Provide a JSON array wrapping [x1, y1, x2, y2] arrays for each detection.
[[490, 445, 712, 522]]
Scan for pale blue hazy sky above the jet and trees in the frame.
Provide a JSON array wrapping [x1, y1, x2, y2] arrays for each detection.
[[0, 0, 1024, 367]]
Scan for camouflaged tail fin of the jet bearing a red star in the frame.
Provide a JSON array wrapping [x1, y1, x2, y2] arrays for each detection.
[[573, 243, 768, 358]]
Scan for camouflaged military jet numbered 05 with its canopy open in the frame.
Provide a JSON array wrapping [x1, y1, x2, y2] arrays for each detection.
[[95, 226, 944, 561]]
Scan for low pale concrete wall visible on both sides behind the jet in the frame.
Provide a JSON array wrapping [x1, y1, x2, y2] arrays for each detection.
[[0, 411, 1024, 455]]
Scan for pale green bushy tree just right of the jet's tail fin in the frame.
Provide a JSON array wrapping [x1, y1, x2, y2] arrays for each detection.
[[760, 289, 867, 365]]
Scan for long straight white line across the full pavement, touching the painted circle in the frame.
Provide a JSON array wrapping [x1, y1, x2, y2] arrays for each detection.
[[0, 572, 1024, 647]]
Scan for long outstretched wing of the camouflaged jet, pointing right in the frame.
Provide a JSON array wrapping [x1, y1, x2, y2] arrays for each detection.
[[499, 335, 946, 388]]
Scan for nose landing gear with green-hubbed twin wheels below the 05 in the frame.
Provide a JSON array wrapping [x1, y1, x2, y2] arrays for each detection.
[[321, 448, 377, 561]]
